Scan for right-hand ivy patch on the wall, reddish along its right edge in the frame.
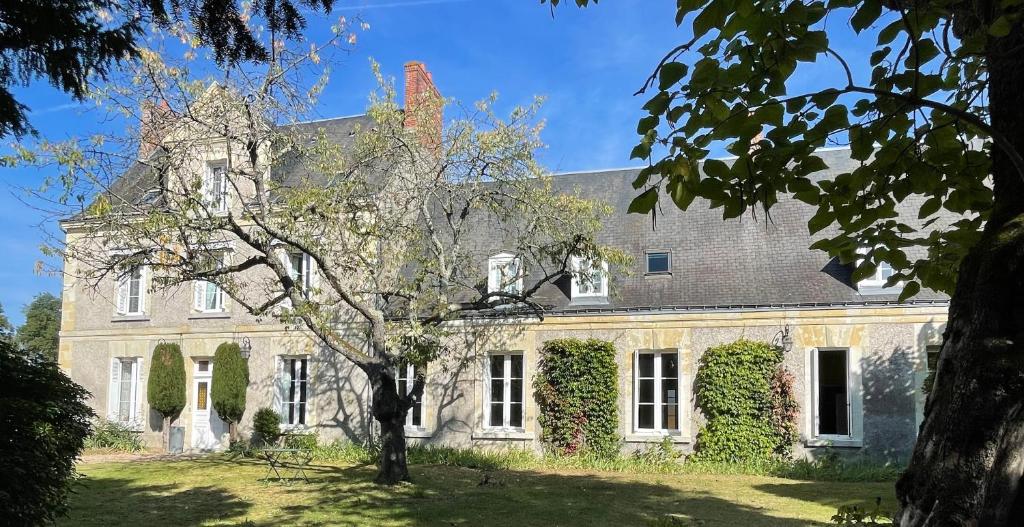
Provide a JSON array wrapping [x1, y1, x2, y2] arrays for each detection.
[[694, 339, 798, 463]]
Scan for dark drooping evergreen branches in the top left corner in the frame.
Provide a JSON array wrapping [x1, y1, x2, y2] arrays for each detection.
[[0, 0, 334, 136]]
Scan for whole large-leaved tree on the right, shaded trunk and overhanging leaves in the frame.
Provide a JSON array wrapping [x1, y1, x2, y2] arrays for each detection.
[[542, 0, 1024, 527]]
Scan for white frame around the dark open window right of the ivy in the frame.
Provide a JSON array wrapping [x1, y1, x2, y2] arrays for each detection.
[[803, 346, 864, 447]]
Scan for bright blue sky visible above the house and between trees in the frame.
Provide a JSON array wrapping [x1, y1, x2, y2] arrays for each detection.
[[0, 0, 873, 323]]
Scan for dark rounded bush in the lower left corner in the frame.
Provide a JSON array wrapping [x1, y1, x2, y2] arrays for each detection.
[[0, 341, 93, 525]]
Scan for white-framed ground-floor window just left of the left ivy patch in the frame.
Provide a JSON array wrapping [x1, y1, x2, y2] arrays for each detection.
[[483, 353, 525, 430]]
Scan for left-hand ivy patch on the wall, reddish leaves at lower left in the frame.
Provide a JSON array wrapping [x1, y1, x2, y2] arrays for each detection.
[[534, 339, 620, 456]]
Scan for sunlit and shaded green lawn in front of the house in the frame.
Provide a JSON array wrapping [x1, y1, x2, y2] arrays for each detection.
[[62, 455, 894, 527]]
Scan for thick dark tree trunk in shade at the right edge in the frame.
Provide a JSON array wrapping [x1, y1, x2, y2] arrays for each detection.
[[896, 18, 1024, 527]]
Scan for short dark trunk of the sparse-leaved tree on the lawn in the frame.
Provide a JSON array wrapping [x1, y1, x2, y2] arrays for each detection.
[[370, 368, 411, 485]]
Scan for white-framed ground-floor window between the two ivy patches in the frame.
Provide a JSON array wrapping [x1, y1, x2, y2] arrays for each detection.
[[633, 350, 683, 434]]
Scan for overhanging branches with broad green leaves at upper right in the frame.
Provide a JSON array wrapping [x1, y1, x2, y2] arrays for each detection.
[[552, 0, 1024, 298]]
